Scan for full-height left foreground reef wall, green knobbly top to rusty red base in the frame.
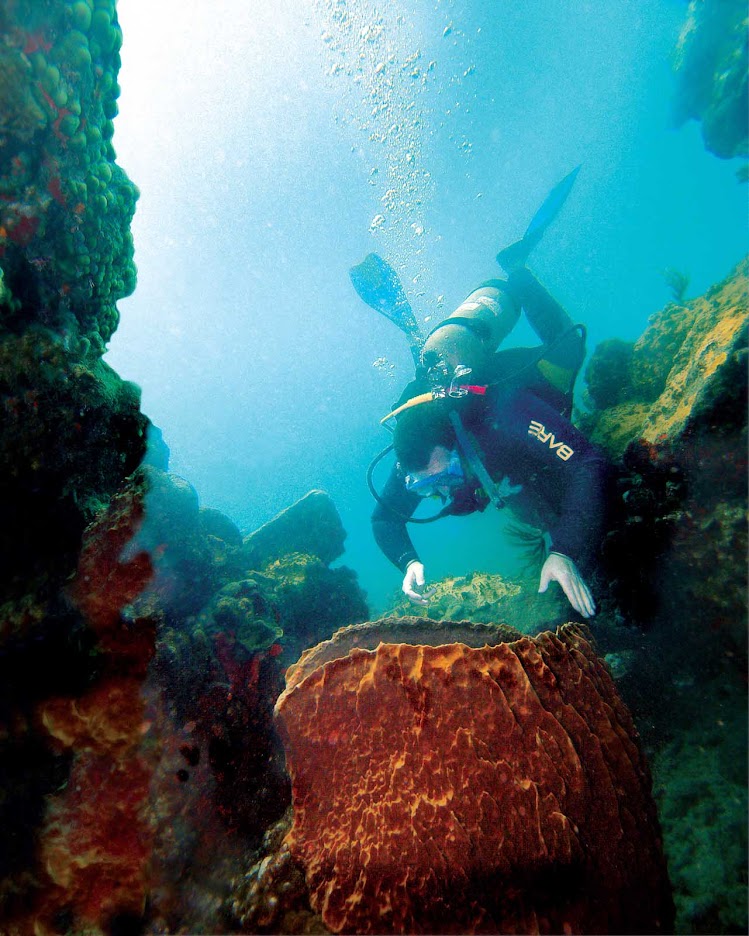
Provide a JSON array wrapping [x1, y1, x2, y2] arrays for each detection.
[[0, 0, 153, 932]]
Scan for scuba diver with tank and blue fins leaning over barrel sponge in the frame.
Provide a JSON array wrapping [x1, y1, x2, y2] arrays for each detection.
[[351, 167, 607, 618]]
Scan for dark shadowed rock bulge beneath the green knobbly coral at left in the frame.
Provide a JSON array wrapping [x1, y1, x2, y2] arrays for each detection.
[[0, 328, 148, 620]]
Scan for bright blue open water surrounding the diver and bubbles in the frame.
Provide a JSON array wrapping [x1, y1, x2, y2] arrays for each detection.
[[107, 0, 748, 609]]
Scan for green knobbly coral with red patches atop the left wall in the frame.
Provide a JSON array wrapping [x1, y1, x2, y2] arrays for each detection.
[[0, 0, 138, 353]]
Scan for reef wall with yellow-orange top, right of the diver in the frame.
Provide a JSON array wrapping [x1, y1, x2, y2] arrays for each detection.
[[581, 260, 749, 933]]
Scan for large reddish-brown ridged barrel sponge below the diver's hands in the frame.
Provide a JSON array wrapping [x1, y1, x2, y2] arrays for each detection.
[[276, 618, 673, 933]]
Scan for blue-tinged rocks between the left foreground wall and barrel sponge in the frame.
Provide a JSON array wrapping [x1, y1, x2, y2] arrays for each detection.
[[141, 494, 367, 916]]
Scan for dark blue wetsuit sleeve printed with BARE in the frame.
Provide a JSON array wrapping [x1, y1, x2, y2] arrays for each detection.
[[498, 392, 609, 568]]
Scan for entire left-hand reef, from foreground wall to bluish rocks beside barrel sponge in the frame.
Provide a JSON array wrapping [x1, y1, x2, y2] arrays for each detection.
[[0, 0, 368, 936]]
